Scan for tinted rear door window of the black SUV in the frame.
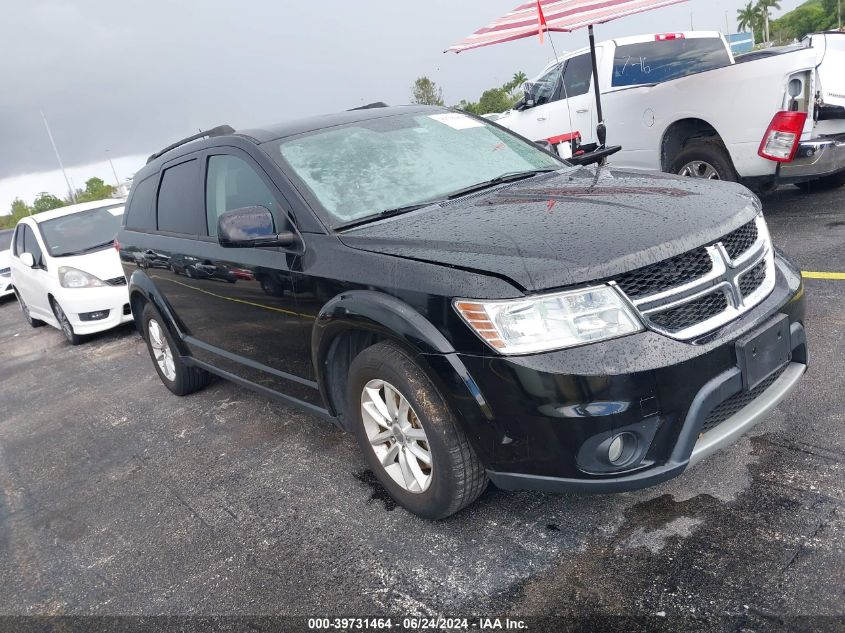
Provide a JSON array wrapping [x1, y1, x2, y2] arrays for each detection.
[[157, 159, 205, 235]]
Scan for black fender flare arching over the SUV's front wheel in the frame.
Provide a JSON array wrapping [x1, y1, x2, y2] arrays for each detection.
[[311, 290, 493, 420]]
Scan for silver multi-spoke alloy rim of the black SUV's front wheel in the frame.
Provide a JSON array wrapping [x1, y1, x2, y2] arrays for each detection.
[[361, 379, 434, 493]]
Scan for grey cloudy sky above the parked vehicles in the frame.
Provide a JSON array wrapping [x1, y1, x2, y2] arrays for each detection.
[[0, 0, 801, 213]]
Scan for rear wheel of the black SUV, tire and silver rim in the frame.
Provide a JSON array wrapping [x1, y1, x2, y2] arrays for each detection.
[[141, 303, 211, 396]]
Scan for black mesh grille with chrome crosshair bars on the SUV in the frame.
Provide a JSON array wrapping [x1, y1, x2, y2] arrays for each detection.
[[613, 216, 775, 340]]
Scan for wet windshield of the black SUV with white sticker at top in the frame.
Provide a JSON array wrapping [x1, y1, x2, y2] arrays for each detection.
[[270, 111, 566, 226]]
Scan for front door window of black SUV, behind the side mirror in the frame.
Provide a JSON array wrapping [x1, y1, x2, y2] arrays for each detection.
[[205, 155, 287, 236]]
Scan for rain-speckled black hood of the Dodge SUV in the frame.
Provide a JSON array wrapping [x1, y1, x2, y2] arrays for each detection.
[[339, 167, 759, 292]]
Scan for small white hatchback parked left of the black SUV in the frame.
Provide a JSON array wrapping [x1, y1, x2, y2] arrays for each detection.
[[11, 200, 132, 345]]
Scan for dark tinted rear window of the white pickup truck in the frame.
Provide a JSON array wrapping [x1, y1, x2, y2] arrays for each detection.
[[611, 37, 731, 86]]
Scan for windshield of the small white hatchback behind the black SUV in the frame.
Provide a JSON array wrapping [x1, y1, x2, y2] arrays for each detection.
[[38, 203, 123, 257]]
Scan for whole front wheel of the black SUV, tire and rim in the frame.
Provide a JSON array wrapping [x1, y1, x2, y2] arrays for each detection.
[[347, 342, 487, 519]]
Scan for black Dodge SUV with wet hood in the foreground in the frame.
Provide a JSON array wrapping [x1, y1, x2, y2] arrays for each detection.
[[118, 106, 807, 518]]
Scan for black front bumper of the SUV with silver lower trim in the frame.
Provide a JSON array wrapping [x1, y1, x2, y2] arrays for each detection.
[[438, 257, 807, 492]]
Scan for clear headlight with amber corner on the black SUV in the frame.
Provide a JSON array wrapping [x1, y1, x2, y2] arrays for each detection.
[[454, 286, 643, 354]]
